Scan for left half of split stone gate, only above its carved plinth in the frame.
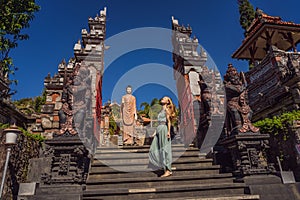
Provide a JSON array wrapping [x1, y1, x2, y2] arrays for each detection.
[[33, 9, 106, 139]]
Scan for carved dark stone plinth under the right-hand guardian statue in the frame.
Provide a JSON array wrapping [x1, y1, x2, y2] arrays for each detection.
[[220, 132, 274, 176]]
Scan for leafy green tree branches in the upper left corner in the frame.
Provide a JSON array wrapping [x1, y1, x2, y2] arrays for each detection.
[[0, 0, 40, 81]]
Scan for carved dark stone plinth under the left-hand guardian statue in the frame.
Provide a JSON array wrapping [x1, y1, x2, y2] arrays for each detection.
[[37, 135, 90, 185]]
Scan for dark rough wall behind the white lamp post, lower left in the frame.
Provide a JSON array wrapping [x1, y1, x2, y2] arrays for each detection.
[[0, 129, 42, 200]]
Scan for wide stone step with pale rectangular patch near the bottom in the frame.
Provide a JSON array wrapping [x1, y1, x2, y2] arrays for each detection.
[[83, 183, 246, 200]]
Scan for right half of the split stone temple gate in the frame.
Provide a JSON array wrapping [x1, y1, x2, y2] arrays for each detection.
[[172, 17, 225, 153]]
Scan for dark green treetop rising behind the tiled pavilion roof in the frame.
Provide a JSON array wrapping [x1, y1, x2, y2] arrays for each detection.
[[238, 0, 255, 37]]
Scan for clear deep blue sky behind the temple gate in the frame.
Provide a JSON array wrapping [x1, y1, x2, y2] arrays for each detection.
[[11, 0, 300, 108]]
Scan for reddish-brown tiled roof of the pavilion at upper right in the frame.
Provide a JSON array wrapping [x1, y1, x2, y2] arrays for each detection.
[[232, 9, 300, 63]]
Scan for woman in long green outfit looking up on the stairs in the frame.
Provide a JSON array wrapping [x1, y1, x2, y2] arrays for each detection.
[[149, 97, 175, 177]]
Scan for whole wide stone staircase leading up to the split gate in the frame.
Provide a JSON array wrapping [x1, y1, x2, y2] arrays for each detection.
[[83, 144, 259, 200]]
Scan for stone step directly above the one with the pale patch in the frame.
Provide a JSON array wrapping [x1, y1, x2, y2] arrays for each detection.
[[87, 173, 233, 190]]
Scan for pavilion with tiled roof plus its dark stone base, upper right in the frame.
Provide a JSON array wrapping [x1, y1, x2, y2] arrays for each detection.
[[232, 9, 300, 121]]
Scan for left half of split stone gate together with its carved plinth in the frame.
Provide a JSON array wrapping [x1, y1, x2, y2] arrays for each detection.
[[23, 8, 106, 193]]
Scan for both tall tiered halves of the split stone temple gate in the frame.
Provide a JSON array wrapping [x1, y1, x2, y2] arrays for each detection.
[[21, 8, 224, 193]]
